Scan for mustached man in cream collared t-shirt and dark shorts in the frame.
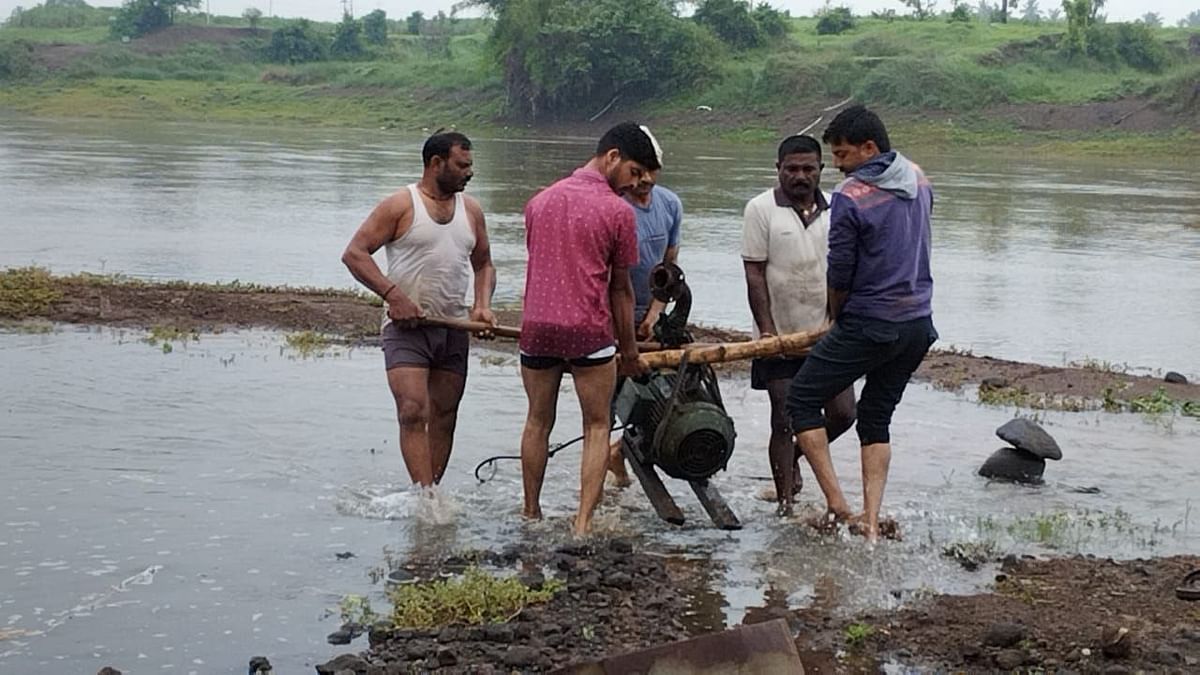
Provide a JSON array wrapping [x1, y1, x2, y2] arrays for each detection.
[[742, 136, 854, 515]]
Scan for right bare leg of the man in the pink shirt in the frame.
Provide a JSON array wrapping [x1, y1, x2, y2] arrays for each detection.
[[571, 360, 617, 536]]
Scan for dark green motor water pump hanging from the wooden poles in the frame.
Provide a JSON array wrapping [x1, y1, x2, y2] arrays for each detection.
[[614, 264, 742, 530]]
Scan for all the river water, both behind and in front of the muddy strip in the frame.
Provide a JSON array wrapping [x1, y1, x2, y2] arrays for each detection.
[[0, 120, 1200, 674]]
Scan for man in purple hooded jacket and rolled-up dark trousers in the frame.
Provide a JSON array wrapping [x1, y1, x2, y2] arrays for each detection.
[[787, 106, 937, 542]]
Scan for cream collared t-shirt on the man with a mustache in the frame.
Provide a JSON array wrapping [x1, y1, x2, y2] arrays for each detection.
[[742, 190, 829, 338]]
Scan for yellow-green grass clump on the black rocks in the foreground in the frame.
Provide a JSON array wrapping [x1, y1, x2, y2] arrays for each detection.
[[388, 566, 565, 628]]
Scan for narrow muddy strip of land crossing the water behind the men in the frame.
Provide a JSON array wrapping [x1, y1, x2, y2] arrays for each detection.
[[0, 268, 1200, 414]]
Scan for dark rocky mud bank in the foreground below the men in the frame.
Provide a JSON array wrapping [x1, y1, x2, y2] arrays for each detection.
[[317, 539, 1200, 674]]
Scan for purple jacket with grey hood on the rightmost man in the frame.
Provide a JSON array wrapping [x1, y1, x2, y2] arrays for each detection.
[[828, 151, 934, 322]]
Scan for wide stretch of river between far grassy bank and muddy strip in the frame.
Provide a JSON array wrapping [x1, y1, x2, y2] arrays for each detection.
[[0, 119, 1200, 376]]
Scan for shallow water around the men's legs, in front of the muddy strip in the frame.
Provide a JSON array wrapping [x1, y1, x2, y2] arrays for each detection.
[[0, 327, 1200, 674]]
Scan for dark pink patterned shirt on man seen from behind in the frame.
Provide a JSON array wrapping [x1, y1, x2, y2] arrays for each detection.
[[520, 167, 637, 359]]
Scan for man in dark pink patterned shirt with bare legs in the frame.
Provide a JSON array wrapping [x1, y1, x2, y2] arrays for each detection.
[[521, 123, 659, 536]]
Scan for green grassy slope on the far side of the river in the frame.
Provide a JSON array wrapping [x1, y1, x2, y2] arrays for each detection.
[[0, 13, 1200, 155]]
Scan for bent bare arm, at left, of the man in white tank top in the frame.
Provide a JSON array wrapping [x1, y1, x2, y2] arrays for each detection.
[[342, 191, 421, 321]]
